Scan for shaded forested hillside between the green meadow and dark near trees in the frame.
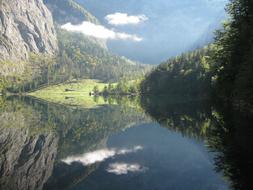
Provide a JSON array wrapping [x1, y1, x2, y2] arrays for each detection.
[[141, 45, 213, 96]]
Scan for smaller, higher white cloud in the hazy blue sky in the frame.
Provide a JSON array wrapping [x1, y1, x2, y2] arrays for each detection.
[[105, 13, 148, 26]]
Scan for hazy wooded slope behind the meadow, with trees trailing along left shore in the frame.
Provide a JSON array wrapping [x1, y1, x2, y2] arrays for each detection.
[[19, 29, 151, 92]]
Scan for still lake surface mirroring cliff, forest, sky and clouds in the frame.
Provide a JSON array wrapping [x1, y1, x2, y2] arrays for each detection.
[[0, 97, 253, 190]]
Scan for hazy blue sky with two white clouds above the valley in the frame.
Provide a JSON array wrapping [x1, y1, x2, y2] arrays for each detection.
[[72, 0, 227, 64]]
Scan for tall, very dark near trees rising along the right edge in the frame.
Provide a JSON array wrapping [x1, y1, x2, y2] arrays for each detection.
[[213, 0, 253, 107]]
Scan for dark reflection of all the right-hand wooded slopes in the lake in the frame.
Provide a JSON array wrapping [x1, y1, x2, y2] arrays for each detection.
[[141, 97, 253, 190]]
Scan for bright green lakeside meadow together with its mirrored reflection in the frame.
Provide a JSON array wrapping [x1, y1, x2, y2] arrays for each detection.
[[29, 79, 107, 108]]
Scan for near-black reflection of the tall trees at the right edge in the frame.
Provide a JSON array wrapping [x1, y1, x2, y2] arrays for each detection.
[[207, 104, 253, 190]]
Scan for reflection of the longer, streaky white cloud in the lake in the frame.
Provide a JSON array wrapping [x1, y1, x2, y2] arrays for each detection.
[[62, 146, 143, 166]]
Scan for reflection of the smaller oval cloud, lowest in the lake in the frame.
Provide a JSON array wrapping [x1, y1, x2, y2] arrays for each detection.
[[106, 163, 147, 175]]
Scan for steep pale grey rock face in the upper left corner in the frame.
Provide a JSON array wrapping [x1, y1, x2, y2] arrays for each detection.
[[0, 0, 58, 61]]
